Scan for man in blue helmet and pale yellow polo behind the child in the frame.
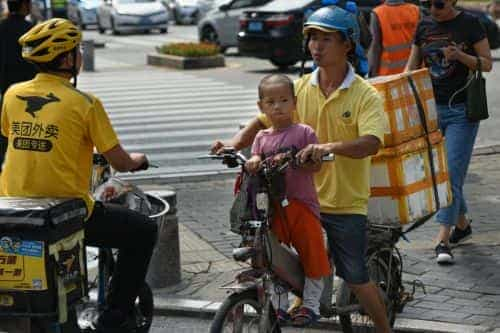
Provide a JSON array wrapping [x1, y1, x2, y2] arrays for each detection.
[[212, 7, 391, 333]]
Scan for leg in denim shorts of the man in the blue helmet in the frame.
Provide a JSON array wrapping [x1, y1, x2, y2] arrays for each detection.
[[321, 214, 391, 333]]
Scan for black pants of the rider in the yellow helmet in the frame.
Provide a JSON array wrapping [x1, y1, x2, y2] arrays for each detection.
[[85, 202, 158, 315]]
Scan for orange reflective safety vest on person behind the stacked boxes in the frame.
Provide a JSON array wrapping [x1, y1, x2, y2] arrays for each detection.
[[368, 0, 420, 77]]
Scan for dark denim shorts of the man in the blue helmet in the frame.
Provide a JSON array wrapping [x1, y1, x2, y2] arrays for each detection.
[[321, 214, 370, 284]]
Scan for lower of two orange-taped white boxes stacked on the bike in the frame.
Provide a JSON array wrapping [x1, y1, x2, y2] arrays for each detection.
[[368, 131, 452, 226]]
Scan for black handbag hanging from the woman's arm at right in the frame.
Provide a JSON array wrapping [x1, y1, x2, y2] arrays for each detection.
[[465, 57, 490, 121]]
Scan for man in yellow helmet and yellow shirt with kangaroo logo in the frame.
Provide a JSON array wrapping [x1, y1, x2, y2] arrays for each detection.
[[0, 19, 157, 333]]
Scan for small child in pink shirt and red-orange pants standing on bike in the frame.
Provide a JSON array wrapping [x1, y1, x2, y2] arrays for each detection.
[[245, 74, 330, 327]]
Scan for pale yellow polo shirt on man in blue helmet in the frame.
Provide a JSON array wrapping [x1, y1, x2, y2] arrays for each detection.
[[258, 66, 386, 215]]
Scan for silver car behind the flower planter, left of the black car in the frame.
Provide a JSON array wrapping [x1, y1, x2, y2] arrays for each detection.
[[198, 0, 272, 51]]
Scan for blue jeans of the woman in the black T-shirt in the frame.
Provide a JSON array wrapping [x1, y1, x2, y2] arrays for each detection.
[[436, 104, 479, 226]]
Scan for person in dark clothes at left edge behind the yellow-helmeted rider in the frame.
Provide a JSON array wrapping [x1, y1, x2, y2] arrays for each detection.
[[0, 0, 37, 169]]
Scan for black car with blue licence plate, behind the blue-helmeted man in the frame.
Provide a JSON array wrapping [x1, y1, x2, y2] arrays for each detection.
[[238, 0, 321, 69]]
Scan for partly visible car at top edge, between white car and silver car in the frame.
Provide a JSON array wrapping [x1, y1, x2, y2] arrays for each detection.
[[163, 0, 213, 24]]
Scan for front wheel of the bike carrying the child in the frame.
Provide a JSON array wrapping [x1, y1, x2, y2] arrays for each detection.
[[210, 289, 281, 333]]
